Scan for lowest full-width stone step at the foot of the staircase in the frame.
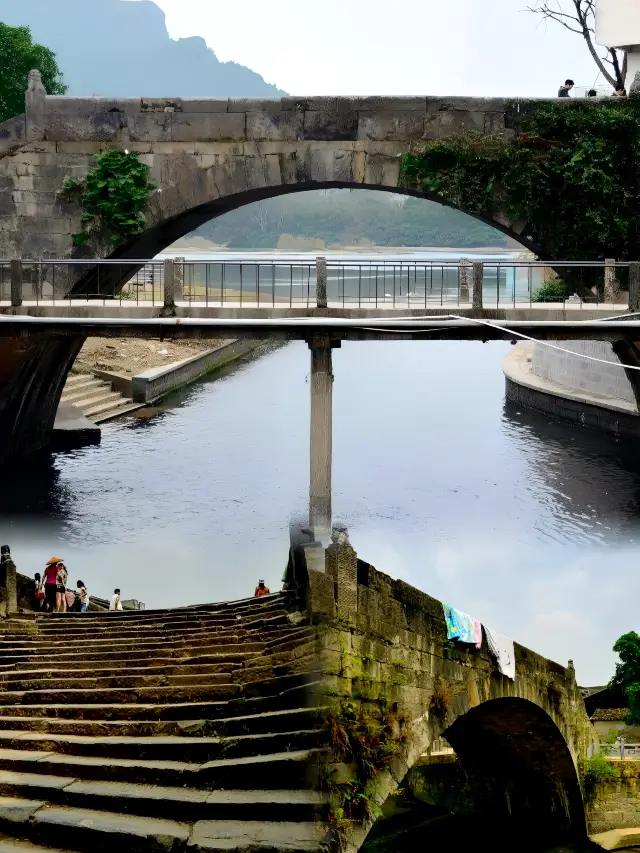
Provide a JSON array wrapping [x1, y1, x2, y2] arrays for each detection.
[[0, 797, 324, 853]]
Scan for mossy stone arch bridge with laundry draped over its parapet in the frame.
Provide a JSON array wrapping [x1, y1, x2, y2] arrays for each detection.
[[298, 543, 593, 851]]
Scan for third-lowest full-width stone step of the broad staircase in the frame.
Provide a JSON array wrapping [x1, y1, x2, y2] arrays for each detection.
[[0, 749, 323, 790]]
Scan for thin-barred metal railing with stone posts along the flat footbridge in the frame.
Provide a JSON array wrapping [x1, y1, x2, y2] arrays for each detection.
[[0, 257, 640, 311]]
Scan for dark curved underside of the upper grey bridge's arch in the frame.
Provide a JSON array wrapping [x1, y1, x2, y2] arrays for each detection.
[[70, 180, 538, 295]]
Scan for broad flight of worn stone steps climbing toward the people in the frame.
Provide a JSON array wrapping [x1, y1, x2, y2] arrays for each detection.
[[0, 594, 324, 853]]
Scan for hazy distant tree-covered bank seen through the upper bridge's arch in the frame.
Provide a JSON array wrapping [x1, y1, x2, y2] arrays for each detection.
[[194, 190, 507, 249]]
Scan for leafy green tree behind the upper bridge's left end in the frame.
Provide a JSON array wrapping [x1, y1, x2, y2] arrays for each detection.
[[0, 23, 67, 122]]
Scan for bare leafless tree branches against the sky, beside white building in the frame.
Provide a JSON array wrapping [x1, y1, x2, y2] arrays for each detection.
[[526, 0, 627, 89]]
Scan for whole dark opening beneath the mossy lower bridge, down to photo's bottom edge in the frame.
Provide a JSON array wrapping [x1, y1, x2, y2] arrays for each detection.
[[361, 697, 587, 853]]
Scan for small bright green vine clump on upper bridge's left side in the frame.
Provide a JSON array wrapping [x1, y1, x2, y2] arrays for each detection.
[[58, 149, 158, 246]]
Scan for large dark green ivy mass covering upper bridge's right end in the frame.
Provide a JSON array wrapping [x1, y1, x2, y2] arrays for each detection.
[[401, 100, 640, 260]]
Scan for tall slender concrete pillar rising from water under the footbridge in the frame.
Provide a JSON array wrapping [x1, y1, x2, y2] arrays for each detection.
[[309, 338, 333, 539]]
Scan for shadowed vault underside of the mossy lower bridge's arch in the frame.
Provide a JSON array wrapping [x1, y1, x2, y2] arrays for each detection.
[[360, 698, 587, 851]]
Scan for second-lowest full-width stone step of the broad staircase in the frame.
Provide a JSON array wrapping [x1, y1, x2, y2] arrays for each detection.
[[0, 770, 325, 822]]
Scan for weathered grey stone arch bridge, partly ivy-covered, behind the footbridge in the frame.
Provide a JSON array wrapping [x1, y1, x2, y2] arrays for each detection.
[[0, 78, 552, 276]]
